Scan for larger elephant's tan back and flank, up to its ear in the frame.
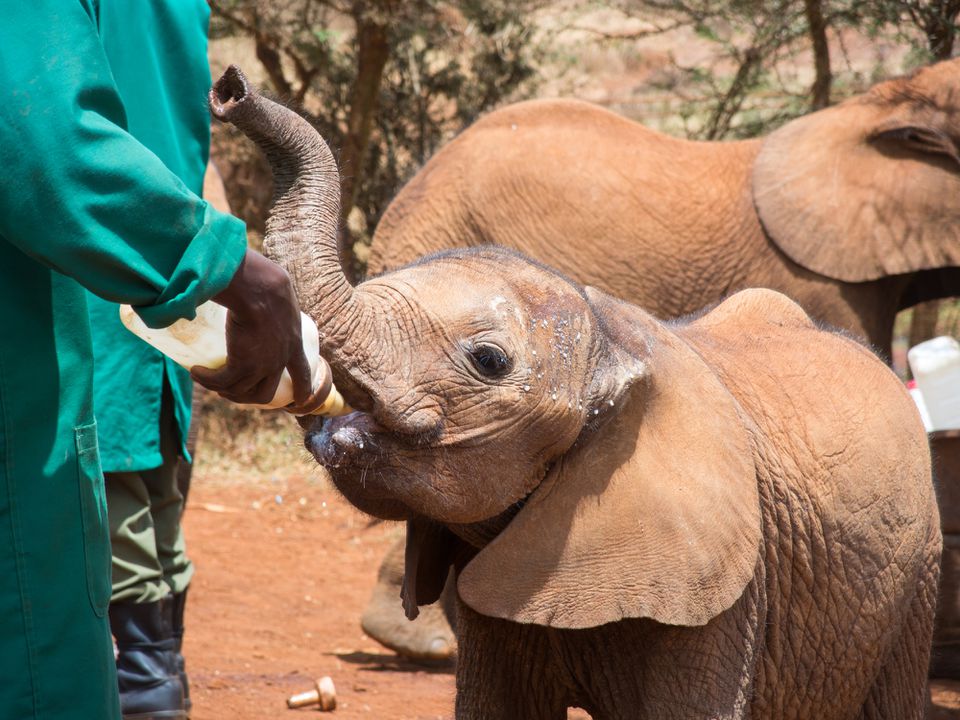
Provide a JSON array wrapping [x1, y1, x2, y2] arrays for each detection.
[[369, 100, 764, 317]]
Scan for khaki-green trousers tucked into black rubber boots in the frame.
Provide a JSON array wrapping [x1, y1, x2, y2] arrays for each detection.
[[104, 384, 193, 603]]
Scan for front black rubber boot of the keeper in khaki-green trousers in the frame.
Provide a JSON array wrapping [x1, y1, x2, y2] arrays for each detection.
[[110, 595, 187, 720]]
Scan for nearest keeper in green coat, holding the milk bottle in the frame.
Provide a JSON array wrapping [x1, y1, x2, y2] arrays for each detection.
[[0, 0, 322, 720]]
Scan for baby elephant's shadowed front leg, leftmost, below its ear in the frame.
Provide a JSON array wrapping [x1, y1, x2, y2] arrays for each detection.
[[456, 601, 571, 720]]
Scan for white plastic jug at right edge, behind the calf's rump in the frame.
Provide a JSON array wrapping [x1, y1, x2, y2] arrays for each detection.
[[907, 336, 960, 432]]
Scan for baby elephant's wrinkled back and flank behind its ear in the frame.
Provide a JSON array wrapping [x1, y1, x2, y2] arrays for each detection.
[[681, 292, 940, 717]]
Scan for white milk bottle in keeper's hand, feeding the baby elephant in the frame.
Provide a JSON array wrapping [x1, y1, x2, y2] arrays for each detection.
[[120, 300, 350, 416]]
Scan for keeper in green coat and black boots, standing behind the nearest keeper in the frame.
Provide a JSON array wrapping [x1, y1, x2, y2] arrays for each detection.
[[87, 0, 231, 718]]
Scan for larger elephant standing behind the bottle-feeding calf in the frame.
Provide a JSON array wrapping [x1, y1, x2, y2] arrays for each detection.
[[363, 59, 960, 657]]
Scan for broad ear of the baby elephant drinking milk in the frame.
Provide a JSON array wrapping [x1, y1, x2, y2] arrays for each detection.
[[458, 288, 760, 628]]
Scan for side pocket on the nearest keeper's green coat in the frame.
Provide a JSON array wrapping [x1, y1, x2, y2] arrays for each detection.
[[73, 422, 111, 617]]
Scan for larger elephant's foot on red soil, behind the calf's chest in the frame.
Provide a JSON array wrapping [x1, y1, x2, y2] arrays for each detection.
[[360, 537, 456, 663]]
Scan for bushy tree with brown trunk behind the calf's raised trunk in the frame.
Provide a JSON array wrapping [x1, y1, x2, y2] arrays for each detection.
[[208, 0, 544, 276]]
